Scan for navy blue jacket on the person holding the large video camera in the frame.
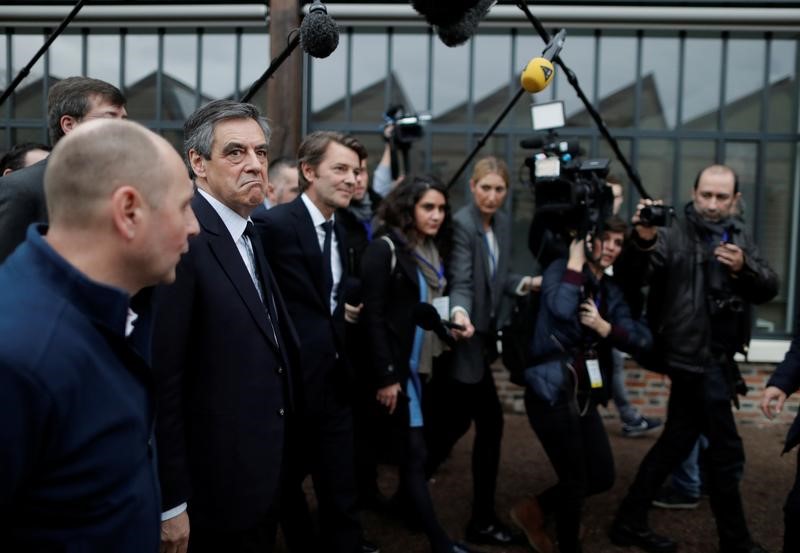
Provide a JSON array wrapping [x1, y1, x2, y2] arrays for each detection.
[[525, 259, 653, 405]]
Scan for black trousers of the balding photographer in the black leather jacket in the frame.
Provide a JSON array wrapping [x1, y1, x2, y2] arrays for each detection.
[[617, 366, 751, 553]]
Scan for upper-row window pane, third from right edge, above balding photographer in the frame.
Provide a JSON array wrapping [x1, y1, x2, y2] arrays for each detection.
[[681, 37, 722, 130]]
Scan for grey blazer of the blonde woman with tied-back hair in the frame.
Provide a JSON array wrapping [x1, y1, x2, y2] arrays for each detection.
[[447, 202, 522, 384]]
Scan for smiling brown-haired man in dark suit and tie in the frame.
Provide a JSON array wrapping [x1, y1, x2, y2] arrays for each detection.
[[256, 131, 361, 553]]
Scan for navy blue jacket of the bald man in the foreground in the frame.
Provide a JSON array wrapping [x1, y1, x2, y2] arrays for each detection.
[[0, 226, 160, 553]]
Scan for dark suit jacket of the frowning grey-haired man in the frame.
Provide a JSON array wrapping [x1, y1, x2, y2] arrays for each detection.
[[153, 193, 297, 531]]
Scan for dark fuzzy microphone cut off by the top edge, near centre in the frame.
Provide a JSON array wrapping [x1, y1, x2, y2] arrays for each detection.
[[411, 0, 497, 47]]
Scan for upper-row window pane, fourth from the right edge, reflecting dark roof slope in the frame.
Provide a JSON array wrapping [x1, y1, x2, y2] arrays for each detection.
[[640, 35, 680, 129]]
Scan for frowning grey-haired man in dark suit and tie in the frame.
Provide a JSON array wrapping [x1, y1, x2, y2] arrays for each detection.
[[153, 100, 297, 553]]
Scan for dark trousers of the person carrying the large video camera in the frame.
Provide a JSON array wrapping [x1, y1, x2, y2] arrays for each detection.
[[525, 389, 614, 553]]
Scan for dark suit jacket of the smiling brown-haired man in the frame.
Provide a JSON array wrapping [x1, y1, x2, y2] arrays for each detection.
[[253, 192, 352, 413]]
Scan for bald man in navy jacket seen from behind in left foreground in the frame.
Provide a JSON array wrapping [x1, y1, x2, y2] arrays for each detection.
[[0, 120, 198, 553]]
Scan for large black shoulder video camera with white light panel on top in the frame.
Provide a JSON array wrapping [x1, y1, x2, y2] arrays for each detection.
[[520, 101, 614, 250]]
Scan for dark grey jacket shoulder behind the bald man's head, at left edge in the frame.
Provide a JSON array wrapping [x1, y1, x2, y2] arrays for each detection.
[[0, 159, 47, 263]]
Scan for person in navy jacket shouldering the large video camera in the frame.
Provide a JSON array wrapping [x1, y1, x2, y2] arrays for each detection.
[[511, 217, 651, 553]]
